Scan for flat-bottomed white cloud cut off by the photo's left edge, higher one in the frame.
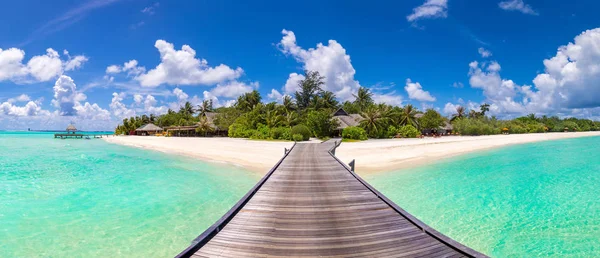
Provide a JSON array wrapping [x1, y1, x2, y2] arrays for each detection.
[[0, 48, 88, 82]]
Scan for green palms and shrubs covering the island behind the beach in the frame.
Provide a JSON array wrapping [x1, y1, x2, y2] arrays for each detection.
[[116, 71, 600, 141]]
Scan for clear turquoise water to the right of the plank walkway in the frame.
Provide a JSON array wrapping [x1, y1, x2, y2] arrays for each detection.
[[365, 137, 600, 257]]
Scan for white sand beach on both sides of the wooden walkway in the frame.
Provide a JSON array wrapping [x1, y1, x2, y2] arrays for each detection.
[[103, 132, 600, 174]]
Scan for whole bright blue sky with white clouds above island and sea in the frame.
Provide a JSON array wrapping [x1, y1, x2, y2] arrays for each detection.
[[0, 0, 600, 130]]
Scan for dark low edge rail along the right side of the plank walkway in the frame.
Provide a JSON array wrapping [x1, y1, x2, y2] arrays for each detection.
[[329, 141, 488, 258]]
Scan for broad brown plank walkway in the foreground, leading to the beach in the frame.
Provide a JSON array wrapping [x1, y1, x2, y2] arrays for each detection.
[[177, 141, 487, 257]]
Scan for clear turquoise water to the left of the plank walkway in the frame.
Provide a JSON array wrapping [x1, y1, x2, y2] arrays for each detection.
[[0, 132, 259, 257]]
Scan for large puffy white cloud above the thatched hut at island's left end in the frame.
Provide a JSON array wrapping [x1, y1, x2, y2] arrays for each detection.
[[132, 40, 244, 87]]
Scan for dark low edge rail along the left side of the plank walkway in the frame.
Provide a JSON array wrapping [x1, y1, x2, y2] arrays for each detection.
[[175, 142, 296, 258]]
